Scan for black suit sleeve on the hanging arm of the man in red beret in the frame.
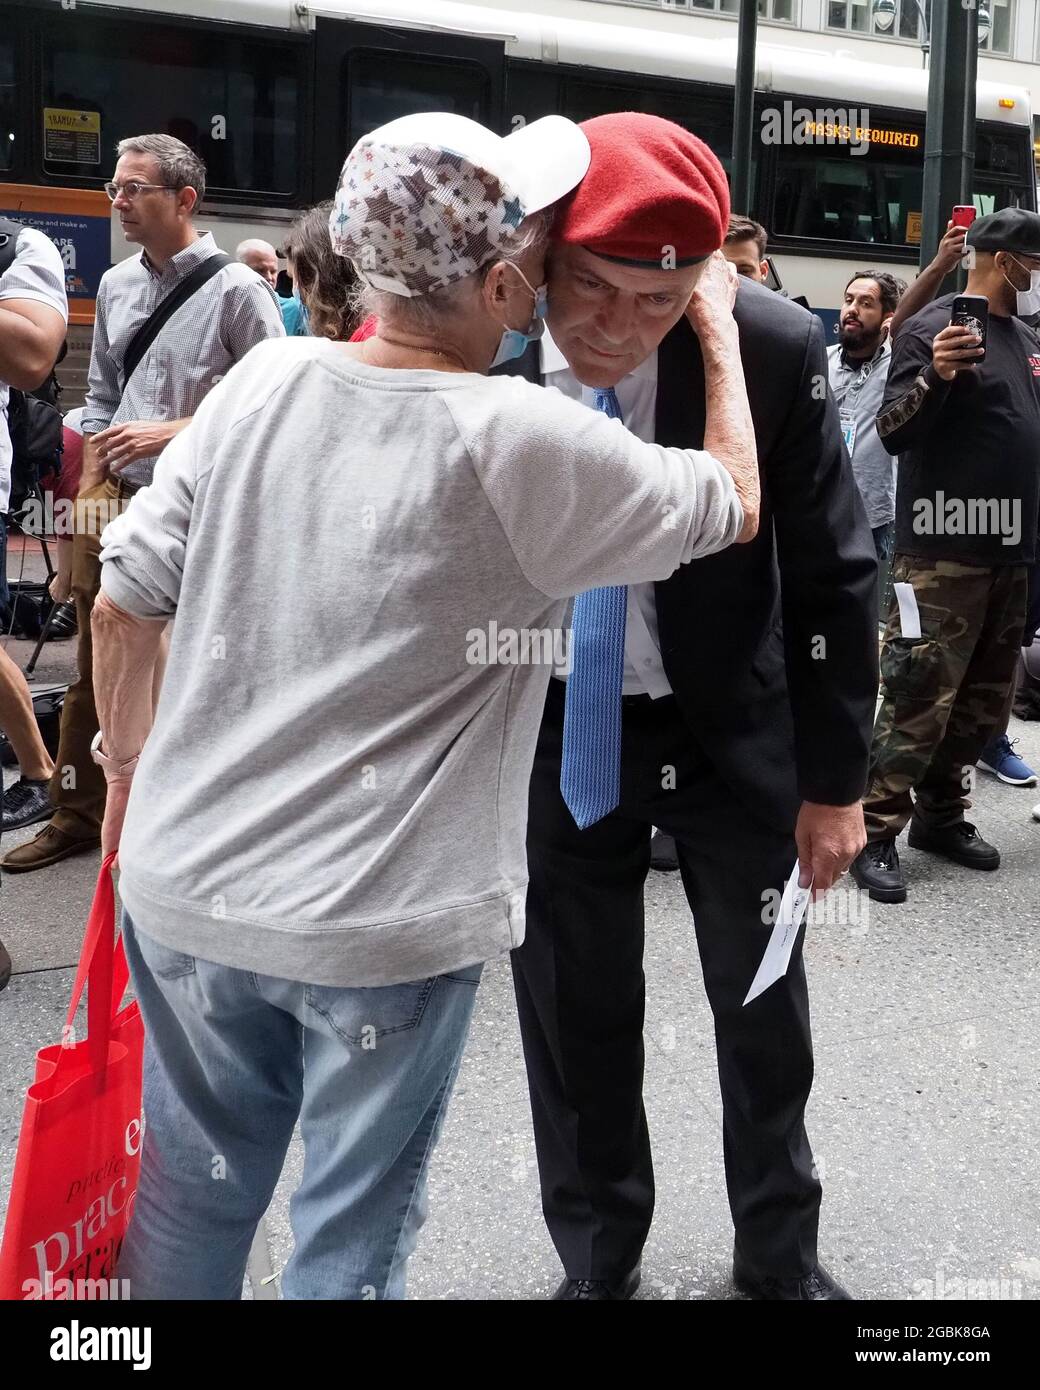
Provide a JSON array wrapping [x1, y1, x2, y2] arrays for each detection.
[[767, 309, 877, 806]]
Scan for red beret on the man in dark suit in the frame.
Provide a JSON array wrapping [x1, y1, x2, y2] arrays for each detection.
[[552, 111, 730, 268]]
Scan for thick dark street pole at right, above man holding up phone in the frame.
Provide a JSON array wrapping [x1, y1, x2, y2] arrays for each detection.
[[920, 4, 979, 283]]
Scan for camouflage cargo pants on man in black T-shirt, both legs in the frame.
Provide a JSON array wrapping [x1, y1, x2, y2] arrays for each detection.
[[863, 555, 1026, 840]]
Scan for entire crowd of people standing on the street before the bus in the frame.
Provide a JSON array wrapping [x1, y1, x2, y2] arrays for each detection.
[[0, 113, 1040, 1301]]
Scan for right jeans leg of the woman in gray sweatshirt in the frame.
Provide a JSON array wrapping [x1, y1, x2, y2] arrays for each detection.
[[282, 965, 481, 1300]]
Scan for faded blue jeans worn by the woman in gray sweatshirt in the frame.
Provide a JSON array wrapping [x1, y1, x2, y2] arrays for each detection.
[[118, 912, 482, 1300]]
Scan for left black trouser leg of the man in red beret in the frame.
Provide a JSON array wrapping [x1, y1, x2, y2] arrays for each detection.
[[512, 681, 653, 1284]]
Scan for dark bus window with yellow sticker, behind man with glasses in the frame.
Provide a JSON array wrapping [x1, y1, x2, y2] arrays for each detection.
[[39, 18, 302, 197]]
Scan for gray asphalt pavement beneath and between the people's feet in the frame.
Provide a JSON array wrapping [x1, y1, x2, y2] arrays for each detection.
[[0, 542, 1040, 1300]]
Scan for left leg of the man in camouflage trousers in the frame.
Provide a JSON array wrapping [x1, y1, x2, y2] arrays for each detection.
[[863, 555, 991, 840]]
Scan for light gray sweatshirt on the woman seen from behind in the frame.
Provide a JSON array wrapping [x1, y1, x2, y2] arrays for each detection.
[[101, 338, 742, 986]]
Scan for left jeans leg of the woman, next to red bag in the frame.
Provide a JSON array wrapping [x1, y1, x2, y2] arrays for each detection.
[[118, 912, 303, 1300]]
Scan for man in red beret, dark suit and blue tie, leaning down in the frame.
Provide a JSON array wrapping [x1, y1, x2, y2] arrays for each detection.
[[494, 113, 877, 1300]]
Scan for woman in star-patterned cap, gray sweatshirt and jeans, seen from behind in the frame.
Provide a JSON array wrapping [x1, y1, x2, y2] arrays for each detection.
[[93, 114, 758, 1298]]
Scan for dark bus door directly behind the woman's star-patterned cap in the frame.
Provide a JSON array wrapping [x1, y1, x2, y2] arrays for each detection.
[[314, 18, 505, 199]]
